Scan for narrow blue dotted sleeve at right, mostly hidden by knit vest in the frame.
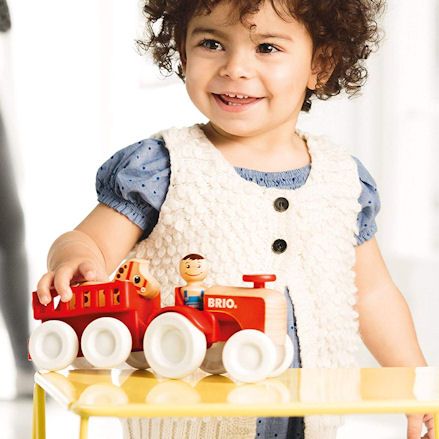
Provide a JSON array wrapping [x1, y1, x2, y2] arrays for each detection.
[[353, 157, 381, 245]]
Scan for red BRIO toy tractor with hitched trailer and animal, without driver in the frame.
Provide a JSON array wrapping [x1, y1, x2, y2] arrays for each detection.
[[29, 259, 294, 382]]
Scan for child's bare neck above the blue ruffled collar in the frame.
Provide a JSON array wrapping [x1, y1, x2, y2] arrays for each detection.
[[201, 123, 311, 172]]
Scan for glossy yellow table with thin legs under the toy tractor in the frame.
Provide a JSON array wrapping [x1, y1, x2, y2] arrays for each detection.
[[32, 367, 439, 439]]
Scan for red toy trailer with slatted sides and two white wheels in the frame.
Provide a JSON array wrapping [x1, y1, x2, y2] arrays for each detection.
[[29, 261, 160, 370]]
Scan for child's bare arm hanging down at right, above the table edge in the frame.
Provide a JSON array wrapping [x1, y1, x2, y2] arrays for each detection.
[[355, 238, 427, 366]]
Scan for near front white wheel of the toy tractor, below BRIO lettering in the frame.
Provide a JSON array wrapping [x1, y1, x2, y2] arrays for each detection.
[[223, 329, 276, 383]]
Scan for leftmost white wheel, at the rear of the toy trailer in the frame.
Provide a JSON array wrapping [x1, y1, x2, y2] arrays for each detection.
[[29, 320, 79, 370]]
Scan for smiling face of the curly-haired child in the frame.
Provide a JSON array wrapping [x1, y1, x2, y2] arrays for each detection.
[[183, 1, 316, 136]]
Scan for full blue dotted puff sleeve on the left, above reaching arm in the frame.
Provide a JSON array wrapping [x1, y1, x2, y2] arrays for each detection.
[[96, 139, 170, 239]]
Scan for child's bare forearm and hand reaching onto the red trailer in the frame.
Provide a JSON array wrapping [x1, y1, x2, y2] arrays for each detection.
[[37, 204, 142, 304]]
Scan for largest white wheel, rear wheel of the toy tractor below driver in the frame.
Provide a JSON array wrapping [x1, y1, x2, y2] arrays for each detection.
[[143, 312, 206, 378]]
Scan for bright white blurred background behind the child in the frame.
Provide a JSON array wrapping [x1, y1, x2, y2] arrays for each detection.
[[0, 0, 439, 438]]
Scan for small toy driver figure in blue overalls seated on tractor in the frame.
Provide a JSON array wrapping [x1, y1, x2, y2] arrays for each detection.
[[180, 253, 208, 309]]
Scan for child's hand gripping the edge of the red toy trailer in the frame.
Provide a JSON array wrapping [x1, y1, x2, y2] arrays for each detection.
[[37, 259, 108, 305]]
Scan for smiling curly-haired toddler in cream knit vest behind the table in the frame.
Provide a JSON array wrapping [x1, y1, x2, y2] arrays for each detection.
[[37, 0, 433, 439]]
